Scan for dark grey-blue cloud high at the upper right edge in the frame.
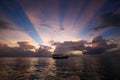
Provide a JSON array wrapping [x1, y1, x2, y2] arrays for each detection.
[[91, 12, 120, 31]]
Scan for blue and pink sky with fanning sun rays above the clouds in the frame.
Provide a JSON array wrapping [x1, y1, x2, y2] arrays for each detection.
[[0, 0, 120, 46]]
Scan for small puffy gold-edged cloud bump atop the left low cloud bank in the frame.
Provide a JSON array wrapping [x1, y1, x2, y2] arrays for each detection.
[[17, 41, 35, 49]]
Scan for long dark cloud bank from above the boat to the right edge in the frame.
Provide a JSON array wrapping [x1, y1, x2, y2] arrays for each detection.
[[52, 36, 117, 54]]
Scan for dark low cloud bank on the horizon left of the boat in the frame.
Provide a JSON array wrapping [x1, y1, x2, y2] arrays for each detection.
[[0, 41, 51, 57]]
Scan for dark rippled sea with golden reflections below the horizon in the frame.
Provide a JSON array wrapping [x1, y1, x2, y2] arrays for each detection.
[[0, 55, 120, 80]]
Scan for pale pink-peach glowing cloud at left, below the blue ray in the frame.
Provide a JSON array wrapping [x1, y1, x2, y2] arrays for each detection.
[[0, 29, 38, 47]]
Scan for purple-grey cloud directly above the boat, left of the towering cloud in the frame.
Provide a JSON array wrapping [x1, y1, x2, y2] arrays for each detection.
[[53, 40, 87, 54]]
